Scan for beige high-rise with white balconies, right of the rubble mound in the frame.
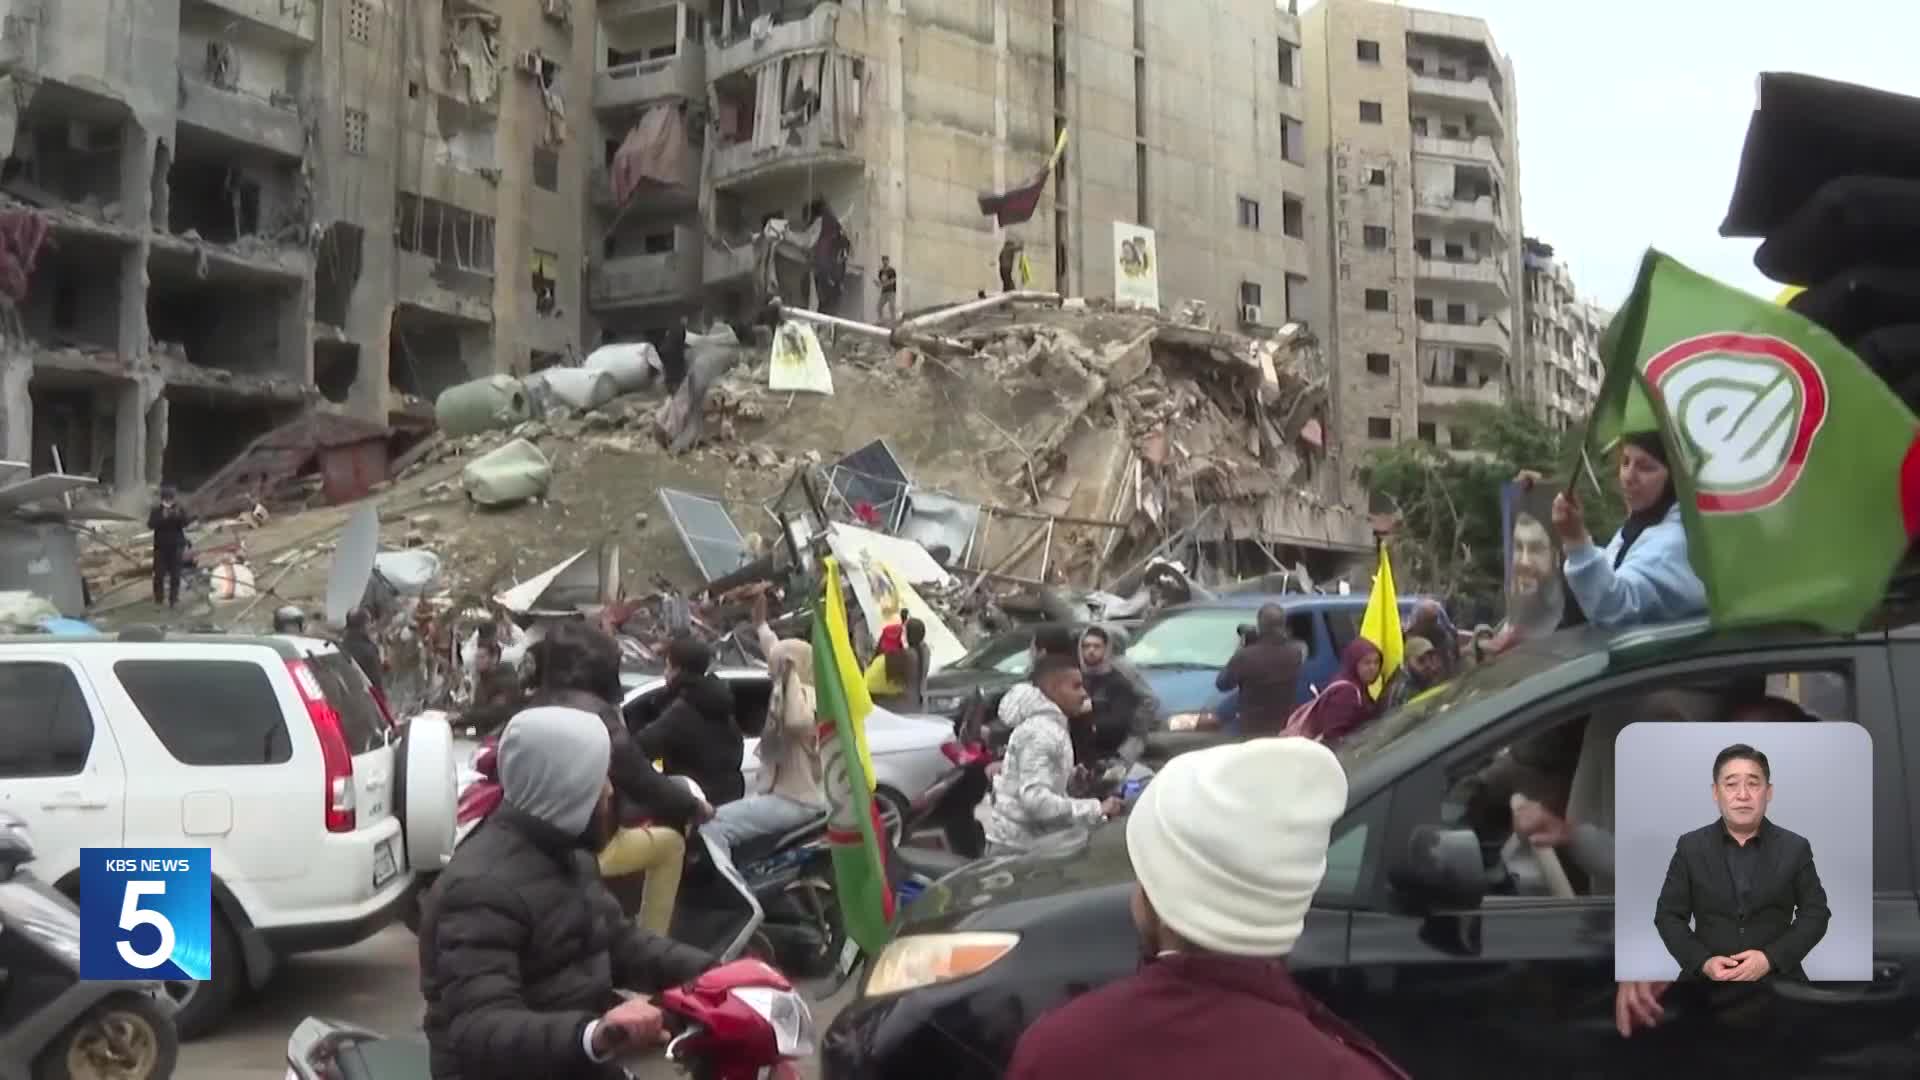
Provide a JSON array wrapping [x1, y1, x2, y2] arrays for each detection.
[[1300, 0, 1524, 488]]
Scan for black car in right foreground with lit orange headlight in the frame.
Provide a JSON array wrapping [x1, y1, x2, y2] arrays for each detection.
[[822, 623, 1920, 1080]]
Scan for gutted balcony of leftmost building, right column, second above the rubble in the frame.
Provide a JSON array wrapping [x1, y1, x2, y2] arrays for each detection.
[[146, 247, 313, 390]]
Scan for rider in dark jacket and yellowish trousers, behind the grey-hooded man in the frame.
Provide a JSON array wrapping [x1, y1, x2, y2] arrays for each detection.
[[526, 621, 714, 934]]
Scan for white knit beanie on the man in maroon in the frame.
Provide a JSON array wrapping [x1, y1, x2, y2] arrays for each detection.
[[1127, 738, 1346, 957]]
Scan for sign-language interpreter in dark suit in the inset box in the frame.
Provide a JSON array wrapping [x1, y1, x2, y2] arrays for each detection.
[[1653, 744, 1830, 982]]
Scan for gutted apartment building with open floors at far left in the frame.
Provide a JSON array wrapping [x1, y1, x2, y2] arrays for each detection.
[[0, 0, 593, 503]]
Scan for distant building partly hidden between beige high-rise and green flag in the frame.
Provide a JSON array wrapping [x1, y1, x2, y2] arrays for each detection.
[[1521, 236, 1613, 430]]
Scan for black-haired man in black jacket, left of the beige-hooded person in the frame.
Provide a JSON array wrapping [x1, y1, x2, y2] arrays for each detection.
[[634, 638, 747, 807]]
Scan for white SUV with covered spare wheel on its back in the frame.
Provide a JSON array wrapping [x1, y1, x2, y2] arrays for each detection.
[[0, 628, 453, 1038]]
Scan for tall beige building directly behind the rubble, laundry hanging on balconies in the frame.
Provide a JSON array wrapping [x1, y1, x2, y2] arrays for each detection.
[[588, 0, 1309, 353]]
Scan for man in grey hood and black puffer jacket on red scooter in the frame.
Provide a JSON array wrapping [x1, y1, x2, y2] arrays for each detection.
[[420, 705, 714, 1080]]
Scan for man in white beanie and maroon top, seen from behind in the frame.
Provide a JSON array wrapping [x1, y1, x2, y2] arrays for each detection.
[[1008, 738, 1405, 1080]]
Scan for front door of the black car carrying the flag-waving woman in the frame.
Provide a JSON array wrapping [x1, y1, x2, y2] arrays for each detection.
[[1336, 644, 1920, 1078]]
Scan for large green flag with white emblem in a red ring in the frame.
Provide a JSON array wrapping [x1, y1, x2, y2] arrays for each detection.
[[1588, 250, 1920, 632]]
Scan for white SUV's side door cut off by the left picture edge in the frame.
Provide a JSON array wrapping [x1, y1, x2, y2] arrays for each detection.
[[0, 653, 127, 882]]
